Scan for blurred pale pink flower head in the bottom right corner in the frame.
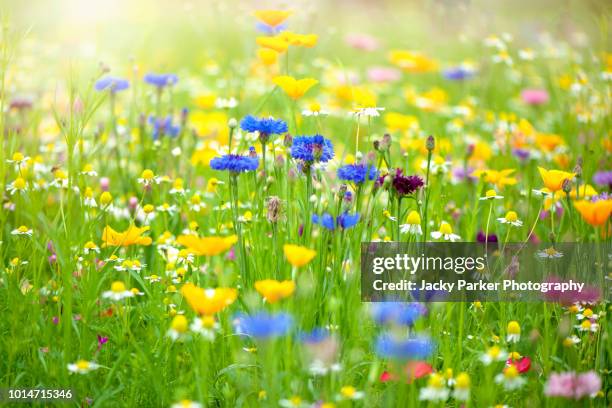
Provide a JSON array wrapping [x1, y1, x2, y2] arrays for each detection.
[[544, 371, 601, 399]]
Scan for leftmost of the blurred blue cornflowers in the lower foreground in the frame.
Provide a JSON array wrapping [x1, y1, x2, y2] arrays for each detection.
[[234, 312, 293, 339]]
